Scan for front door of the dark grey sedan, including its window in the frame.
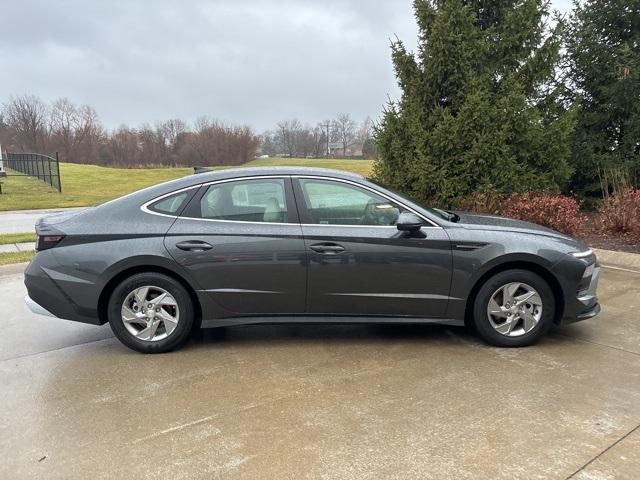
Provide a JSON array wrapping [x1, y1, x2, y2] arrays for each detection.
[[294, 177, 451, 318]]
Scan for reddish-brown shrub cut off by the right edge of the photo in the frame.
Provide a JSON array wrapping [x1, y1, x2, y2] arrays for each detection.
[[598, 188, 640, 235]]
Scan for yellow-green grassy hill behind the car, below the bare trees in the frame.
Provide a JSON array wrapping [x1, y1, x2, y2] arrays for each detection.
[[0, 158, 372, 211]]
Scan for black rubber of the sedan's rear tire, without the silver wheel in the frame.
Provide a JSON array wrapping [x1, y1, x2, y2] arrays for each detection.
[[107, 273, 195, 353]]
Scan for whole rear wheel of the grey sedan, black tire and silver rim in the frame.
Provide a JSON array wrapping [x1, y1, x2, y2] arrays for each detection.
[[107, 272, 196, 353]]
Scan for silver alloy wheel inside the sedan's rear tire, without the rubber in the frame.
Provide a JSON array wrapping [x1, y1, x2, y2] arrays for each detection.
[[120, 285, 180, 342]]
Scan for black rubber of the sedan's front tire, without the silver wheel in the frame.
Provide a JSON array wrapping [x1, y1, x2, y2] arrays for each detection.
[[473, 269, 556, 347]]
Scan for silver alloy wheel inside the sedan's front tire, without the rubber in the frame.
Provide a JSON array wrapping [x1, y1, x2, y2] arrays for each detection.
[[487, 282, 542, 337]]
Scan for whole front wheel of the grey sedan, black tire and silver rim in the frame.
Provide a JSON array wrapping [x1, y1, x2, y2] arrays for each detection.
[[473, 269, 556, 347]]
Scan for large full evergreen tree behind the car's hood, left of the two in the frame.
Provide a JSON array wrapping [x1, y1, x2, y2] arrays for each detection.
[[374, 0, 574, 206]]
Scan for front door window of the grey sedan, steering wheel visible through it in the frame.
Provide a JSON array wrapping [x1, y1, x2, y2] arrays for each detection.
[[300, 179, 402, 225]]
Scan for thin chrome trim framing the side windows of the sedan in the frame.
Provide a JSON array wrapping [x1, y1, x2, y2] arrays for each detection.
[[140, 175, 442, 230]]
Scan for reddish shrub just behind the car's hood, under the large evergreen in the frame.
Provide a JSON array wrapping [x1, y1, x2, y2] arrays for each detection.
[[502, 192, 585, 235]]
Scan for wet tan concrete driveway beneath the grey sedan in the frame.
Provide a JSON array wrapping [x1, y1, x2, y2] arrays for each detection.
[[0, 266, 640, 480]]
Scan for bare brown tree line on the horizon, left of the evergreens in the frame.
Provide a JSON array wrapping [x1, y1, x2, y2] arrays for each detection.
[[0, 95, 376, 167]]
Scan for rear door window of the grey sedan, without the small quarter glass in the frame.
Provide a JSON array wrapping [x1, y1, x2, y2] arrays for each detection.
[[200, 178, 287, 223]]
